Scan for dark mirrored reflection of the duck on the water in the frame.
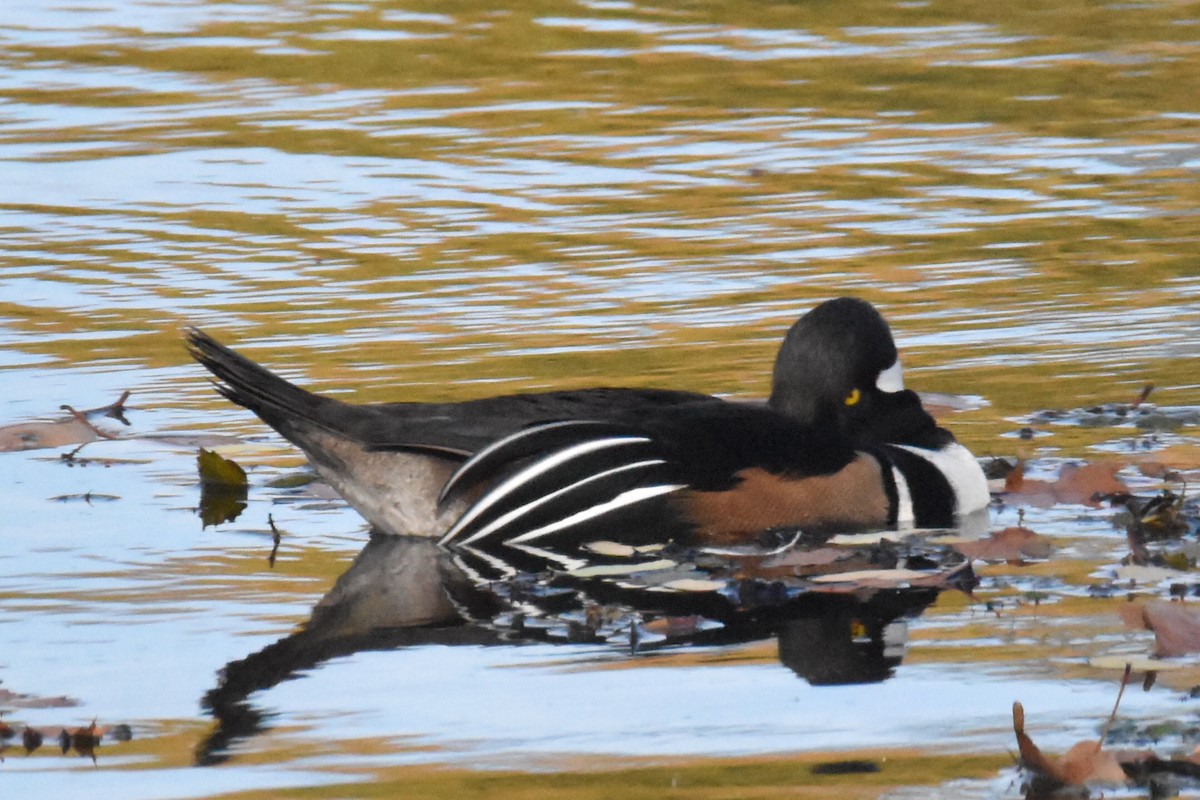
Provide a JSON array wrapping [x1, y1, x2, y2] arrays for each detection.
[[197, 536, 973, 764]]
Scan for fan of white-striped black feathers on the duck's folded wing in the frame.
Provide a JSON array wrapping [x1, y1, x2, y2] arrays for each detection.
[[440, 421, 686, 547]]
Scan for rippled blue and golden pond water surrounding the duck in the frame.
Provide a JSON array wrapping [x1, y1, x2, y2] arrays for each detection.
[[0, 0, 1200, 800]]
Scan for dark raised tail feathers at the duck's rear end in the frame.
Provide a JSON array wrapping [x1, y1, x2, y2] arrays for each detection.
[[186, 327, 334, 438]]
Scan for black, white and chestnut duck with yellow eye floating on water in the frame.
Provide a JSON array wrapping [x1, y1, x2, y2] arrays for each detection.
[[186, 297, 990, 559]]
